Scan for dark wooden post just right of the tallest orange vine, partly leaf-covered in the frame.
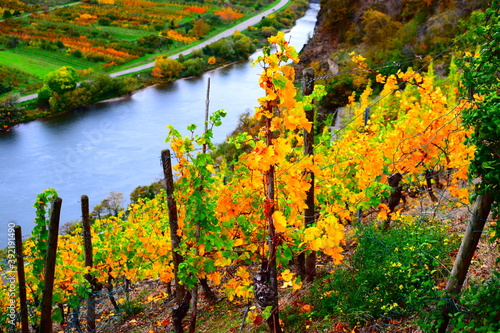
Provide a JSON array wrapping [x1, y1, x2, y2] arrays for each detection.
[[298, 67, 316, 281]]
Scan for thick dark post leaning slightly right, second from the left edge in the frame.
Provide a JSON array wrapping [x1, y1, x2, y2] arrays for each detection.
[[39, 197, 62, 333]]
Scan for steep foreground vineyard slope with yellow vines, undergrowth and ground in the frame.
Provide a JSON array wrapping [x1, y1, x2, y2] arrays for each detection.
[[0, 1, 500, 332]]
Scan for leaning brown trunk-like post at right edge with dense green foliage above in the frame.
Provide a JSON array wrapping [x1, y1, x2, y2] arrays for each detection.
[[436, 8, 500, 333]]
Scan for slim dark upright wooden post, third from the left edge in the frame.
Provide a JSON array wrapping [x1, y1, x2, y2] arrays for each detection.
[[81, 195, 96, 332]]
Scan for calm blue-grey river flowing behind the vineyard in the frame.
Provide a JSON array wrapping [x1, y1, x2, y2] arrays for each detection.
[[0, 3, 319, 247]]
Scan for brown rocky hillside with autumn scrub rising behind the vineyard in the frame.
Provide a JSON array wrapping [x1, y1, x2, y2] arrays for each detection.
[[297, 0, 489, 113]]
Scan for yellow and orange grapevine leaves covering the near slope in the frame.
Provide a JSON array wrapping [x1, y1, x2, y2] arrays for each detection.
[[0, 26, 479, 326]]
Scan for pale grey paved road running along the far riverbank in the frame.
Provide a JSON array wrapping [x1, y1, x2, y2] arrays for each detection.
[[19, 0, 289, 102]]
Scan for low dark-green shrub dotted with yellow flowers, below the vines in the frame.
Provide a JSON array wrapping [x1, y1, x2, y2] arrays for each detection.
[[300, 220, 458, 326]]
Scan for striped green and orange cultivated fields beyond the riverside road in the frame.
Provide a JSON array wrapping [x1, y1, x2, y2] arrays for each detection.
[[0, 0, 270, 94]]
